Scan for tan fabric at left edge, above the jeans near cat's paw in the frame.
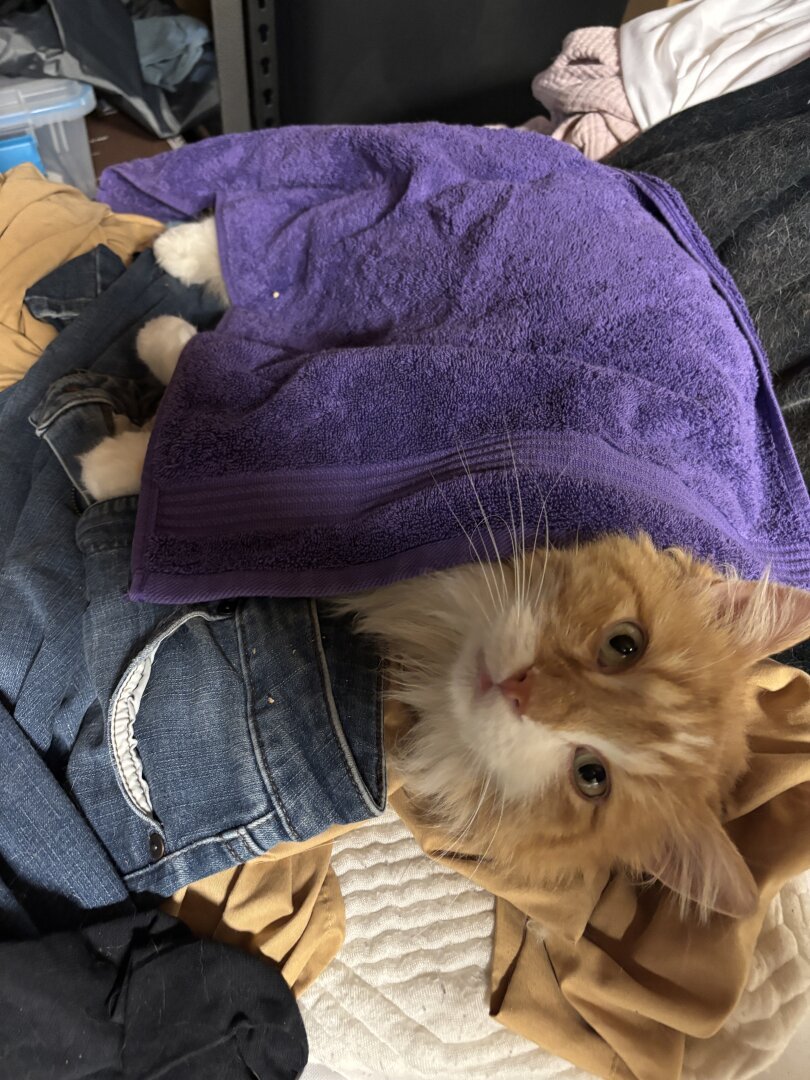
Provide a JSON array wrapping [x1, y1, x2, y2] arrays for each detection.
[[0, 164, 163, 390]]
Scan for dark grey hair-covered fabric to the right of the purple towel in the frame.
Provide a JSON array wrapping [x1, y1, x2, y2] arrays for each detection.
[[607, 59, 810, 672]]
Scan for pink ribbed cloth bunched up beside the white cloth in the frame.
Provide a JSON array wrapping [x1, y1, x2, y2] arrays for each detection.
[[524, 26, 639, 161]]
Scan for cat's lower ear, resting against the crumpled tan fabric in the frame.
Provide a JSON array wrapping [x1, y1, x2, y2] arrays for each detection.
[[647, 811, 759, 918]]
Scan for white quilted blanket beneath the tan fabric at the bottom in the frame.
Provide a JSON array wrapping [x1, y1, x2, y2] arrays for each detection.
[[299, 811, 810, 1080]]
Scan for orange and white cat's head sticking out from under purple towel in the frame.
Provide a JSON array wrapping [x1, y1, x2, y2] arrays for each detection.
[[355, 537, 810, 914]]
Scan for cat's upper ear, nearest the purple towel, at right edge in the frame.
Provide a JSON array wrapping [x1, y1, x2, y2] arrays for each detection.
[[711, 580, 810, 660]]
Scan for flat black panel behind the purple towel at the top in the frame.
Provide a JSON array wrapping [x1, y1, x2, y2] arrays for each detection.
[[275, 0, 625, 125]]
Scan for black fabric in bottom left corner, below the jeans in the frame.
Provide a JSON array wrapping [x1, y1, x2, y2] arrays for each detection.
[[0, 913, 308, 1080]]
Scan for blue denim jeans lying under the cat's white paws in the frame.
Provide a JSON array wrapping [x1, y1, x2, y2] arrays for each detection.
[[0, 255, 386, 935]]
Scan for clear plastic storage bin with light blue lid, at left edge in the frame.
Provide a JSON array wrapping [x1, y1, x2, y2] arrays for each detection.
[[0, 78, 96, 195]]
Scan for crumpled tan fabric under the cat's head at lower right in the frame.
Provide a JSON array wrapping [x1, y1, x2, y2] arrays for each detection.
[[389, 663, 810, 1080]]
